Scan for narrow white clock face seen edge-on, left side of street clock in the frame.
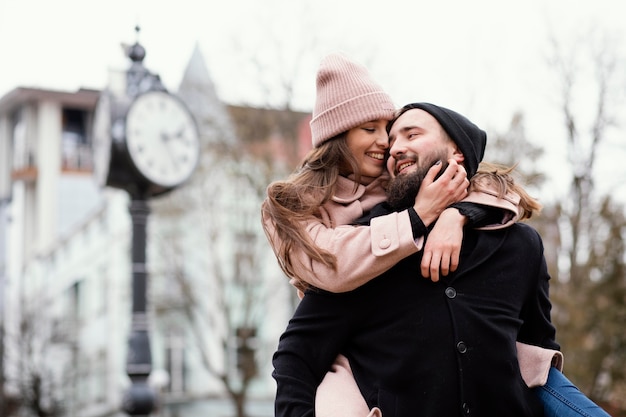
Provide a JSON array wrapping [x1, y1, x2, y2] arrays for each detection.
[[92, 91, 111, 187]]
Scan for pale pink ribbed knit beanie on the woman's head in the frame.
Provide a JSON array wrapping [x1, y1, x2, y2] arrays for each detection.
[[311, 54, 395, 147]]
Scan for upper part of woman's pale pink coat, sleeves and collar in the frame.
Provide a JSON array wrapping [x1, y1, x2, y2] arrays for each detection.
[[263, 179, 519, 292]]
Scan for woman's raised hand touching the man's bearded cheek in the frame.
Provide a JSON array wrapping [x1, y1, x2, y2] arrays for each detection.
[[413, 159, 469, 227]]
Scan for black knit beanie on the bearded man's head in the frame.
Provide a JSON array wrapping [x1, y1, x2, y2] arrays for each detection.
[[387, 103, 487, 178]]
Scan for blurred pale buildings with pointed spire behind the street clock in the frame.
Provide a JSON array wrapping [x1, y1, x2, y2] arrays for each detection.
[[0, 43, 310, 417]]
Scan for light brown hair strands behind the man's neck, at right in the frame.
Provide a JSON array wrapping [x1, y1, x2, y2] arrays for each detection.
[[470, 162, 542, 220]]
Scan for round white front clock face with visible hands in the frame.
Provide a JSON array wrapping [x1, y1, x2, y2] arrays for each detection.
[[126, 91, 200, 187]]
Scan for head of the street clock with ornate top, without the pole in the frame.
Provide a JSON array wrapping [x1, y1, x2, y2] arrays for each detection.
[[92, 44, 200, 198]]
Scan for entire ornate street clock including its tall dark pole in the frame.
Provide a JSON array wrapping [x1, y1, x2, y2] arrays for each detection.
[[93, 28, 199, 416]]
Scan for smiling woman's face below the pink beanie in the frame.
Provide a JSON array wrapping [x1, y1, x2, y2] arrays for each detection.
[[346, 119, 389, 178]]
